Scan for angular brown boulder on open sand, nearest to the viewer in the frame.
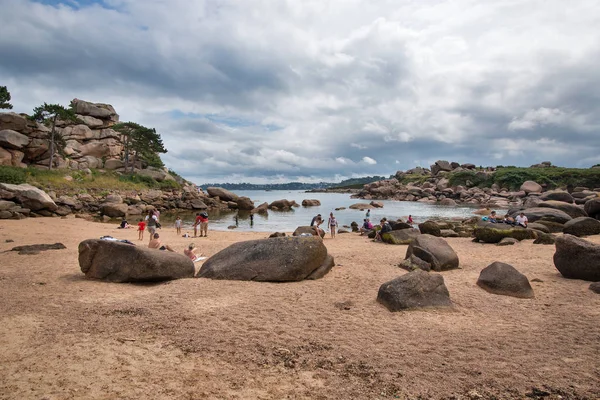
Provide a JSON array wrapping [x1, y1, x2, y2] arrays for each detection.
[[377, 270, 452, 311]]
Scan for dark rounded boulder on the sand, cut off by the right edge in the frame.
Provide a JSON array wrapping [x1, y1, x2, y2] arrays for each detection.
[[554, 234, 600, 282]]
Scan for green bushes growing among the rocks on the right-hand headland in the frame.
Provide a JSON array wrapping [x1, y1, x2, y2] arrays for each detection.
[[449, 167, 600, 190]]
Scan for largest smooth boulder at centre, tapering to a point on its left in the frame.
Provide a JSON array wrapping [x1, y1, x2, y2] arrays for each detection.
[[198, 237, 334, 282]]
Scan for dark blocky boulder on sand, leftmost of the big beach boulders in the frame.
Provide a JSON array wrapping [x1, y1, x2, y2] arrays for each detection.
[[79, 239, 195, 282]]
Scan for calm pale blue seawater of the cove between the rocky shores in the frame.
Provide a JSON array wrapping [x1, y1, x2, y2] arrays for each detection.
[[160, 190, 482, 232]]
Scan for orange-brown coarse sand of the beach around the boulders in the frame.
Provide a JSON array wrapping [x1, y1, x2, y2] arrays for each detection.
[[0, 218, 600, 399]]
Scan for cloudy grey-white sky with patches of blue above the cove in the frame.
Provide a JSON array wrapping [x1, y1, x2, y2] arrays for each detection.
[[0, 0, 600, 183]]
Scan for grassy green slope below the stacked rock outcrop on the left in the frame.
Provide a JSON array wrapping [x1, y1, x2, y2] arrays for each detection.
[[0, 166, 181, 193]]
